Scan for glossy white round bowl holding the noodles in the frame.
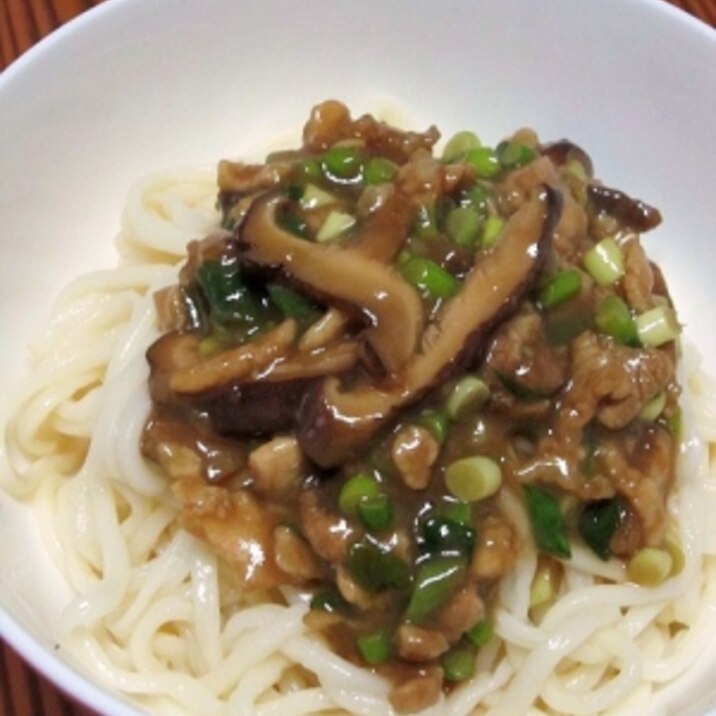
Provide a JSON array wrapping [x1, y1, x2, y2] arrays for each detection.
[[0, 0, 716, 716]]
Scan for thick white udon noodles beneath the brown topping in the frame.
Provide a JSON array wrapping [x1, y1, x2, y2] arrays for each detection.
[[4, 106, 716, 716]]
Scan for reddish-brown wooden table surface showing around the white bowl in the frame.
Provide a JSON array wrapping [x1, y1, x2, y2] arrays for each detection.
[[0, 0, 716, 716]]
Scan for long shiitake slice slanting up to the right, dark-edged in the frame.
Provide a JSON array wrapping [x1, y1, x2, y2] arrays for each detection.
[[297, 187, 561, 467]]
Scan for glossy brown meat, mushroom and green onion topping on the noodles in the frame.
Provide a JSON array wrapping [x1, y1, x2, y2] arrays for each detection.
[[143, 102, 679, 712]]
